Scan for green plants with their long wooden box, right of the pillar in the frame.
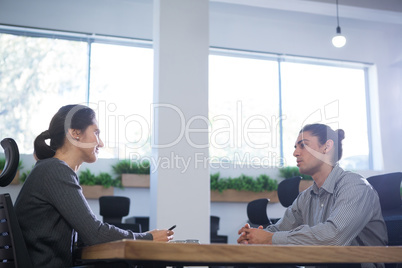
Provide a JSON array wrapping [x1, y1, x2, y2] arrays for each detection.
[[210, 173, 278, 202]]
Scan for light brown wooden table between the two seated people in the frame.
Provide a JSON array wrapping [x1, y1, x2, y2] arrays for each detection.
[[81, 240, 402, 266]]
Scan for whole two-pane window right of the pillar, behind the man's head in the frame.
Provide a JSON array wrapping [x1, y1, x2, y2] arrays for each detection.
[[209, 51, 370, 169]]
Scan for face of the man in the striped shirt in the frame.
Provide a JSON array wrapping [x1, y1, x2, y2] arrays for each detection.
[[293, 131, 325, 176]]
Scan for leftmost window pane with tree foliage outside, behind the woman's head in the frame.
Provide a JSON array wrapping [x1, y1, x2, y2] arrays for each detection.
[[0, 33, 87, 154]]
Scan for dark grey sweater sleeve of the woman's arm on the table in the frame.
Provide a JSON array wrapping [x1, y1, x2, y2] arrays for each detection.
[[44, 163, 153, 245]]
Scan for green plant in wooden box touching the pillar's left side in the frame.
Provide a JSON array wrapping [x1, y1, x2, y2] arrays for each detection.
[[112, 160, 151, 188]]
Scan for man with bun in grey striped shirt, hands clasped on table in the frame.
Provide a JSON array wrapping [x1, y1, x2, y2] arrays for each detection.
[[238, 124, 387, 251]]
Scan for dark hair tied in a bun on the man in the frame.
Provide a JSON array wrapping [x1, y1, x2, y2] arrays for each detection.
[[299, 124, 345, 162]]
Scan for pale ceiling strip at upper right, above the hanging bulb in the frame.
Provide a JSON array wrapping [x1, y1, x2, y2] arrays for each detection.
[[210, 0, 402, 24]]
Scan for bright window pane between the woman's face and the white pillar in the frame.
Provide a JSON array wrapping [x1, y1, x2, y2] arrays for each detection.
[[89, 43, 153, 160]]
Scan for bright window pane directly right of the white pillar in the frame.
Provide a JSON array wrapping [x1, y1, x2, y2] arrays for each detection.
[[209, 55, 279, 165]]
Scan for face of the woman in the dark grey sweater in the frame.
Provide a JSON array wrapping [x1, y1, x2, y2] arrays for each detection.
[[78, 119, 104, 163]]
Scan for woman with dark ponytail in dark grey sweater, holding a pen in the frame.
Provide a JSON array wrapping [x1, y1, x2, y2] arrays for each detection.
[[15, 105, 173, 267]]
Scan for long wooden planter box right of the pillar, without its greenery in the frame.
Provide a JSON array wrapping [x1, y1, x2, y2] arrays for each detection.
[[211, 189, 279, 203]]
